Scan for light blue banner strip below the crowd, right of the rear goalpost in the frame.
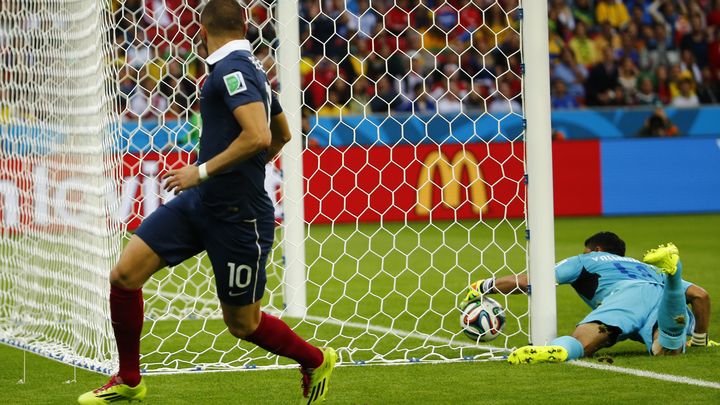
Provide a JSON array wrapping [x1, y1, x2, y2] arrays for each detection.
[[308, 106, 720, 147]]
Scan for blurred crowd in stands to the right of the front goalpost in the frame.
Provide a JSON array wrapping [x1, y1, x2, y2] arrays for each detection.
[[548, 0, 720, 108]]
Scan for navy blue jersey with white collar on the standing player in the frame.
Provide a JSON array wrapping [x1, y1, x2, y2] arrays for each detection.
[[198, 40, 282, 221]]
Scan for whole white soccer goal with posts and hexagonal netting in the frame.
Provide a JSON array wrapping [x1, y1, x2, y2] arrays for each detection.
[[0, 0, 555, 373]]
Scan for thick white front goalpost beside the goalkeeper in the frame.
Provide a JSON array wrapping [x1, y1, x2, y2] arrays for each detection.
[[523, 1, 557, 345]]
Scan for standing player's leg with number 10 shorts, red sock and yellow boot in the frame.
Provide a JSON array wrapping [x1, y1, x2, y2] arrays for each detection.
[[206, 221, 337, 403]]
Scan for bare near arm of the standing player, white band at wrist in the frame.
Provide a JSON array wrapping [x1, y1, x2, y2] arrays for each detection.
[[163, 102, 272, 193]]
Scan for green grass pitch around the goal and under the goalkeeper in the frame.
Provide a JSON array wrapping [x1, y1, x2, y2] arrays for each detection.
[[0, 214, 720, 404]]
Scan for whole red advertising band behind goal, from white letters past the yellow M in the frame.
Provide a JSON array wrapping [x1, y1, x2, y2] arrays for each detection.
[[0, 140, 602, 233]]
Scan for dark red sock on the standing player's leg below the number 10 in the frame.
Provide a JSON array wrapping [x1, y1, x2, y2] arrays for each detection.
[[245, 312, 323, 368]]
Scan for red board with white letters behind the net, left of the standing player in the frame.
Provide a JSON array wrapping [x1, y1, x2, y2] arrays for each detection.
[[0, 152, 195, 234]]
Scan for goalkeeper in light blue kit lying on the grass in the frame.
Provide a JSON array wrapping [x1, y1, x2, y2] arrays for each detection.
[[464, 232, 718, 364]]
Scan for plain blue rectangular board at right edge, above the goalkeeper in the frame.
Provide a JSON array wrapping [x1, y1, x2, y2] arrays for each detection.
[[600, 138, 720, 215]]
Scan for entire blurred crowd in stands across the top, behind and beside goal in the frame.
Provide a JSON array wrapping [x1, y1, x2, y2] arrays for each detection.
[[109, 0, 720, 124]]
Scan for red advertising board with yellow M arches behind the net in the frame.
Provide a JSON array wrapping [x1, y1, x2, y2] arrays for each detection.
[[303, 142, 525, 223]]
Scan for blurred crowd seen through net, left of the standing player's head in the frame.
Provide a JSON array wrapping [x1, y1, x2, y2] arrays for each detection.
[[113, 0, 205, 120]]
